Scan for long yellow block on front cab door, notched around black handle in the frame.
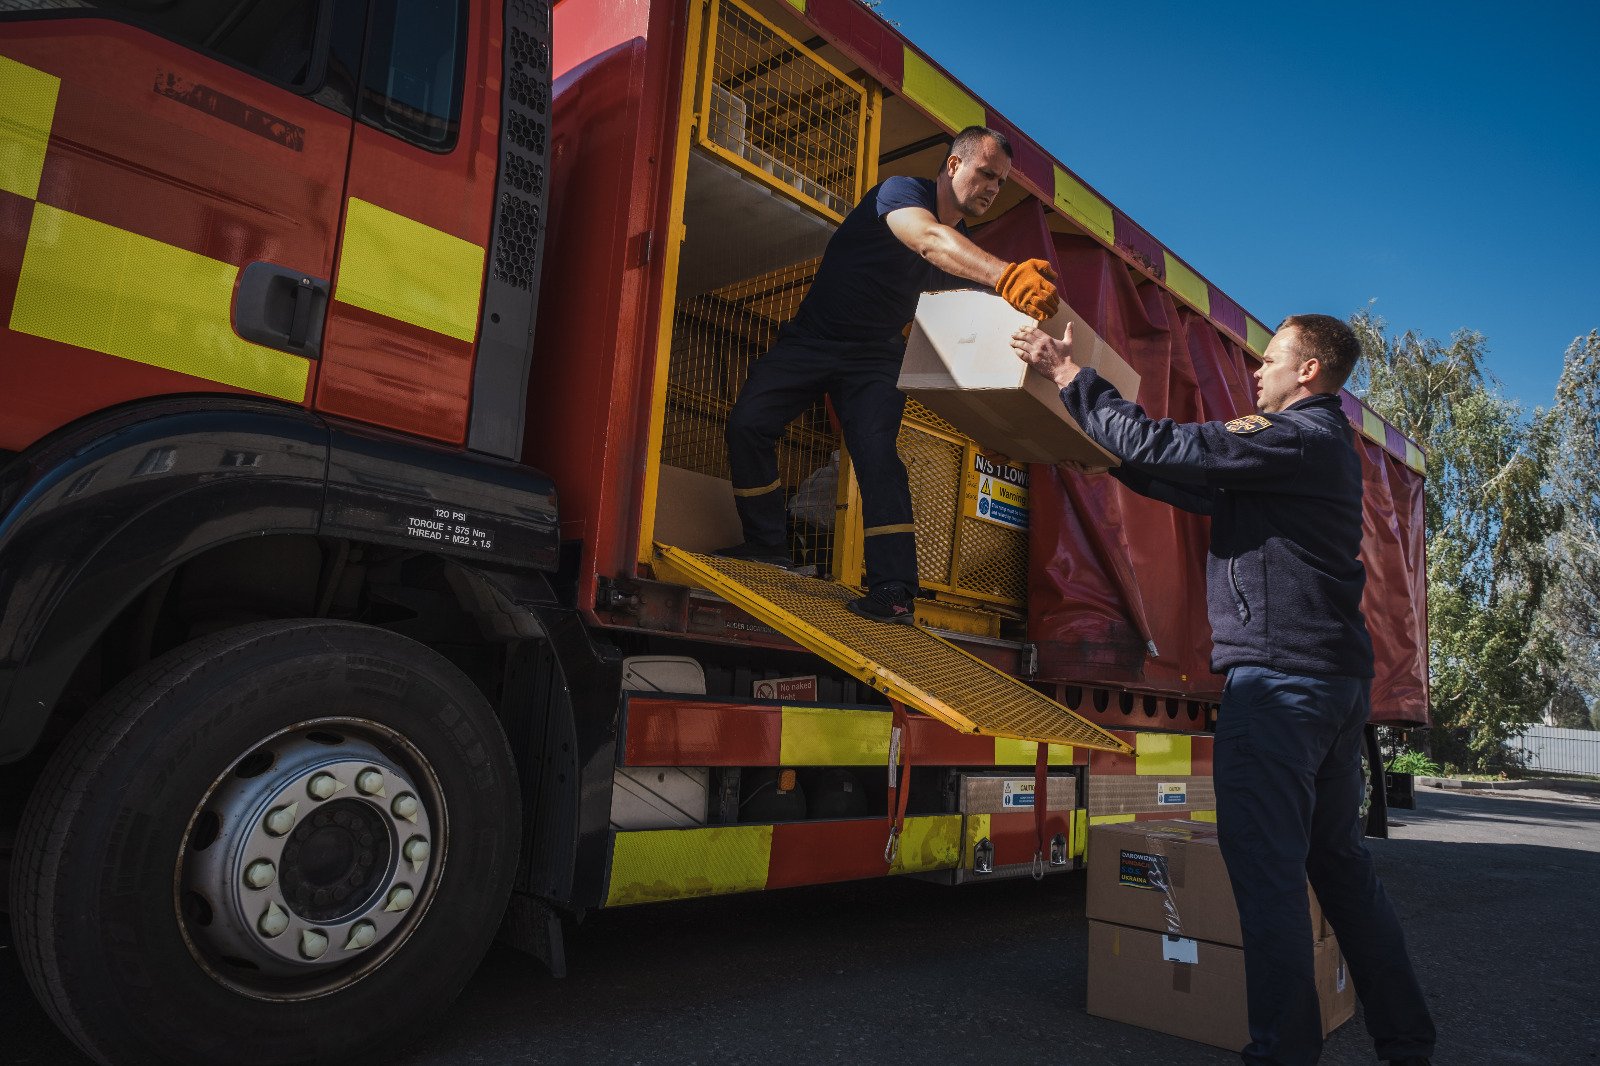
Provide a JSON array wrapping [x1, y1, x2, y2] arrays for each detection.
[[11, 203, 309, 403]]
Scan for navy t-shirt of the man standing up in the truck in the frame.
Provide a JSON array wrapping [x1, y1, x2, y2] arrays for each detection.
[[786, 178, 971, 343]]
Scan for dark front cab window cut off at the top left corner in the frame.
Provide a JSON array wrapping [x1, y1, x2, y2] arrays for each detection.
[[0, 0, 323, 88]]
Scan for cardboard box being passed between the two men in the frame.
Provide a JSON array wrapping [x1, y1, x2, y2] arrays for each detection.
[[899, 290, 1139, 469]]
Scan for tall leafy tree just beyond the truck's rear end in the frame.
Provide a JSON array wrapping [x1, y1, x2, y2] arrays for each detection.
[[1350, 312, 1560, 771]]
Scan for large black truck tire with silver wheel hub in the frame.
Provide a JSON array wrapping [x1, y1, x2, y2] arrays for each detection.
[[11, 619, 520, 1066]]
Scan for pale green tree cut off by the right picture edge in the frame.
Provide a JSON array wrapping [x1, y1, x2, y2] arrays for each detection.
[[1538, 331, 1600, 701]]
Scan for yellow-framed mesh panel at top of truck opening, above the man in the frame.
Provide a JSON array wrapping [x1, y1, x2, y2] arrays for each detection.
[[702, 0, 867, 218]]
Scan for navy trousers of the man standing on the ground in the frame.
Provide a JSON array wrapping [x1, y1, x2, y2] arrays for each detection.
[[1213, 666, 1434, 1063]]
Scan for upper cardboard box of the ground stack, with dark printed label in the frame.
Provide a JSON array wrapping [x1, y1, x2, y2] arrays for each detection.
[[1085, 820, 1330, 948]]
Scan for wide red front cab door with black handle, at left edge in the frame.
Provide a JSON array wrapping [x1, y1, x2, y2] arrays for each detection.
[[0, 0, 362, 448]]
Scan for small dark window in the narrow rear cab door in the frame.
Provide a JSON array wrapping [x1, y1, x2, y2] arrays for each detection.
[[362, 0, 467, 152]]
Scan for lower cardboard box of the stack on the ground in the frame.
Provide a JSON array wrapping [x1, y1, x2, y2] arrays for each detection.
[[1088, 915, 1355, 1052]]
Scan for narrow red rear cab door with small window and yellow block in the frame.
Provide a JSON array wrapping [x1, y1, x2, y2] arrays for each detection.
[[315, 0, 501, 443]]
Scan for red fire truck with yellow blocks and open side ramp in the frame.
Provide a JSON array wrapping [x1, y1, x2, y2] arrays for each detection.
[[0, 0, 1427, 1063]]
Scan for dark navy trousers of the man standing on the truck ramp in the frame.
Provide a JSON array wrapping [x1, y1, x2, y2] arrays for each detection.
[[728, 336, 917, 595]]
